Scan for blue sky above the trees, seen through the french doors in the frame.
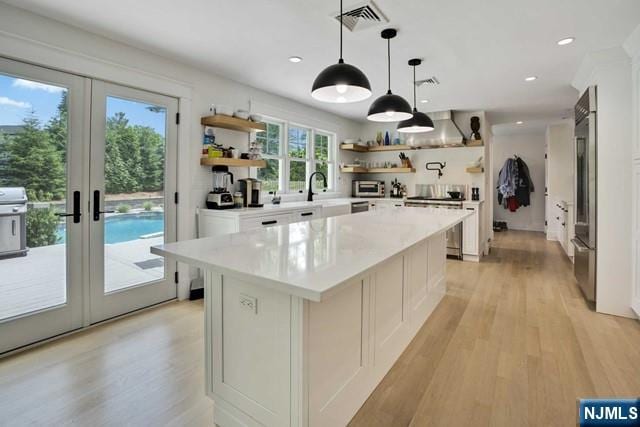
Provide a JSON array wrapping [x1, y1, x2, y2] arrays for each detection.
[[0, 74, 165, 136]]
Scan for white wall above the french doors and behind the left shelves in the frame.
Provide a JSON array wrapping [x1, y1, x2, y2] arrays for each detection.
[[0, 3, 361, 298]]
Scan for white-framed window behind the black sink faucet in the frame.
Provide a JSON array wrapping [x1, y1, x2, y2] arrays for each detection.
[[256, 120, 336, 193]]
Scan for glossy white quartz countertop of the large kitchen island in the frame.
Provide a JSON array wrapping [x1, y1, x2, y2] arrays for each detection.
[[151, 207, 472, 301]]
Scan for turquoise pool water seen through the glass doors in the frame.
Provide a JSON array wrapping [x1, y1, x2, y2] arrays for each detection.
[[57, 212, 164, 243]]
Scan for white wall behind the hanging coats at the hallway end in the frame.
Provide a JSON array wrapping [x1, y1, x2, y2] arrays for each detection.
[[491, 131, 545, 231]]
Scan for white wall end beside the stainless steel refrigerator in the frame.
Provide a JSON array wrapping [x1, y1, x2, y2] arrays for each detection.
[[573, 47, 635, 317]]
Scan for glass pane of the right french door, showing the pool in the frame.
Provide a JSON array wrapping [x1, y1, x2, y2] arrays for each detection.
[[103, 96, 167, 293]]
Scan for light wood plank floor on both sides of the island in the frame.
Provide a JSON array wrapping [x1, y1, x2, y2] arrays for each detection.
[[0, 231, 640, 427]]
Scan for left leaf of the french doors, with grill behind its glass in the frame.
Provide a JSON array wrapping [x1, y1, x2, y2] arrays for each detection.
[[0, 58, 91, 353]]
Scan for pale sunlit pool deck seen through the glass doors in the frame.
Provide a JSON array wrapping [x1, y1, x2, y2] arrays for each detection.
[[0, 237, 164, 319]]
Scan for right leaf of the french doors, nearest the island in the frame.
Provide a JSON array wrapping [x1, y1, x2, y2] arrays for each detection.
[[89, 81, 178, 323]]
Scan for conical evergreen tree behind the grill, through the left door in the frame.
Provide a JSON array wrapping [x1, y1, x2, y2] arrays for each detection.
[[3, 113, 66, 200]]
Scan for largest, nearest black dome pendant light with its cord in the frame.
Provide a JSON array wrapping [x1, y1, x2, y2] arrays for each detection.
[[311, 0, 371, 103]]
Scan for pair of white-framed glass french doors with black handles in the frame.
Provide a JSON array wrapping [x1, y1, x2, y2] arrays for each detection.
[[0, 58, 177, 353]]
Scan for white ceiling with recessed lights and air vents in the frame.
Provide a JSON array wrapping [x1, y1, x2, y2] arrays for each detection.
[[5, 0, 640, 129]]
